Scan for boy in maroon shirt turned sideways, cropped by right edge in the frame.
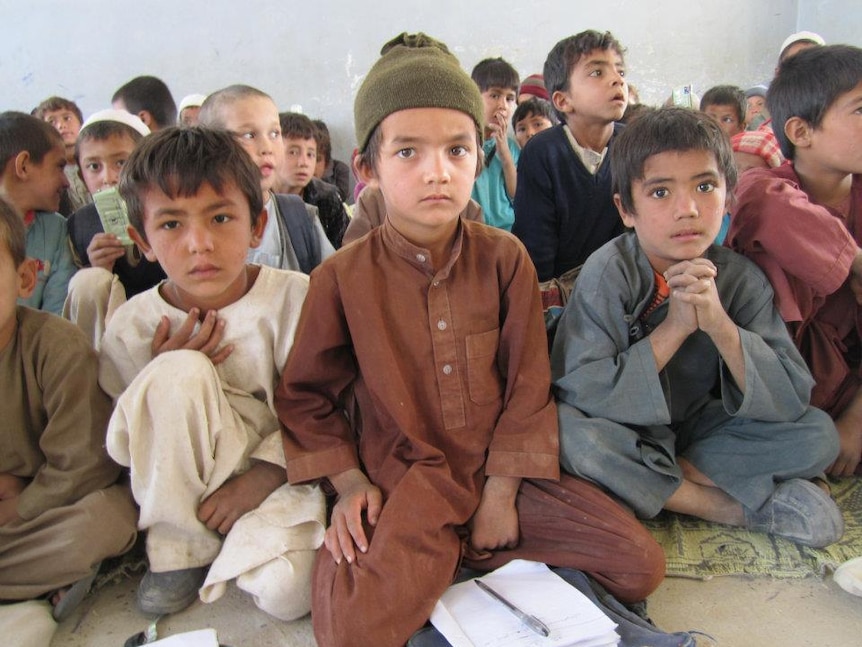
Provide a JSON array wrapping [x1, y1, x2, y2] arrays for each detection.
[[728, 45, 862, 476]]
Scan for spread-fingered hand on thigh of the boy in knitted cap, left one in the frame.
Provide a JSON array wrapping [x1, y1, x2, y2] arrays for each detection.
[[323, 469, 383, 564]]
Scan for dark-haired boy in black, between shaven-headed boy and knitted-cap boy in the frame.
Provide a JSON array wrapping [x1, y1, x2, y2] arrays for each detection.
[[278, 112, 350, 249]]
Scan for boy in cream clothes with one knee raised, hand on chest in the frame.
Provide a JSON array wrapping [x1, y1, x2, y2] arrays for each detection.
[[99, 128, 324, 620]]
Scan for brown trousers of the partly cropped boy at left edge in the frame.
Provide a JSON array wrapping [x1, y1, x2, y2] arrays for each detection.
[[0, 485, 137, 600]]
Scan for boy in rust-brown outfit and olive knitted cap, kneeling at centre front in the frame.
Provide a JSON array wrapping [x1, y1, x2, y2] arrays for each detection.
[[277, 34, 664, 647]]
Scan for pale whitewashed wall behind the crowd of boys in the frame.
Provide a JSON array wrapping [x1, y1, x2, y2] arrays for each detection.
[[0, 0, 862, 159]]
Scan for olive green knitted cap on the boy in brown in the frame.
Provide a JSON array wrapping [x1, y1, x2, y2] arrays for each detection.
[[353, 32, 484, 151]]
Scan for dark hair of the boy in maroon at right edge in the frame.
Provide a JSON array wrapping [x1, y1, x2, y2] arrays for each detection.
[[766, 45, 862, 160]]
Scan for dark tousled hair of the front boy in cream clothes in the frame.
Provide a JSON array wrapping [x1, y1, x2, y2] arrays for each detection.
[[119, 126, 264, 240]]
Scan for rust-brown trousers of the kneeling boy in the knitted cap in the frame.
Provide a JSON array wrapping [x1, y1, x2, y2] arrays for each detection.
[[311, 474, 665, 647]]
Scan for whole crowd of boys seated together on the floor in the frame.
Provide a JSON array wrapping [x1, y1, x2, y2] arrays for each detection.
[[0, 22, 862, 646]]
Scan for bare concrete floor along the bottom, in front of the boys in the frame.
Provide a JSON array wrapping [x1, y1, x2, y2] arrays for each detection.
[[44, 577, 862, 647]]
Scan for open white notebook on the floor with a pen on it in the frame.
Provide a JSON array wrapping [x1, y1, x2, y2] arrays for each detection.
[[431, 560, 620, 647]]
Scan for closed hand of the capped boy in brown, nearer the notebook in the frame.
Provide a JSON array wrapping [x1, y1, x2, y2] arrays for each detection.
[[467, 476, 521, 551]]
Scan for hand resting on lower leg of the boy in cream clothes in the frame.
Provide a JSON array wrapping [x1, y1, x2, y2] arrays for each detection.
[[198, 462, 287, 535]]
